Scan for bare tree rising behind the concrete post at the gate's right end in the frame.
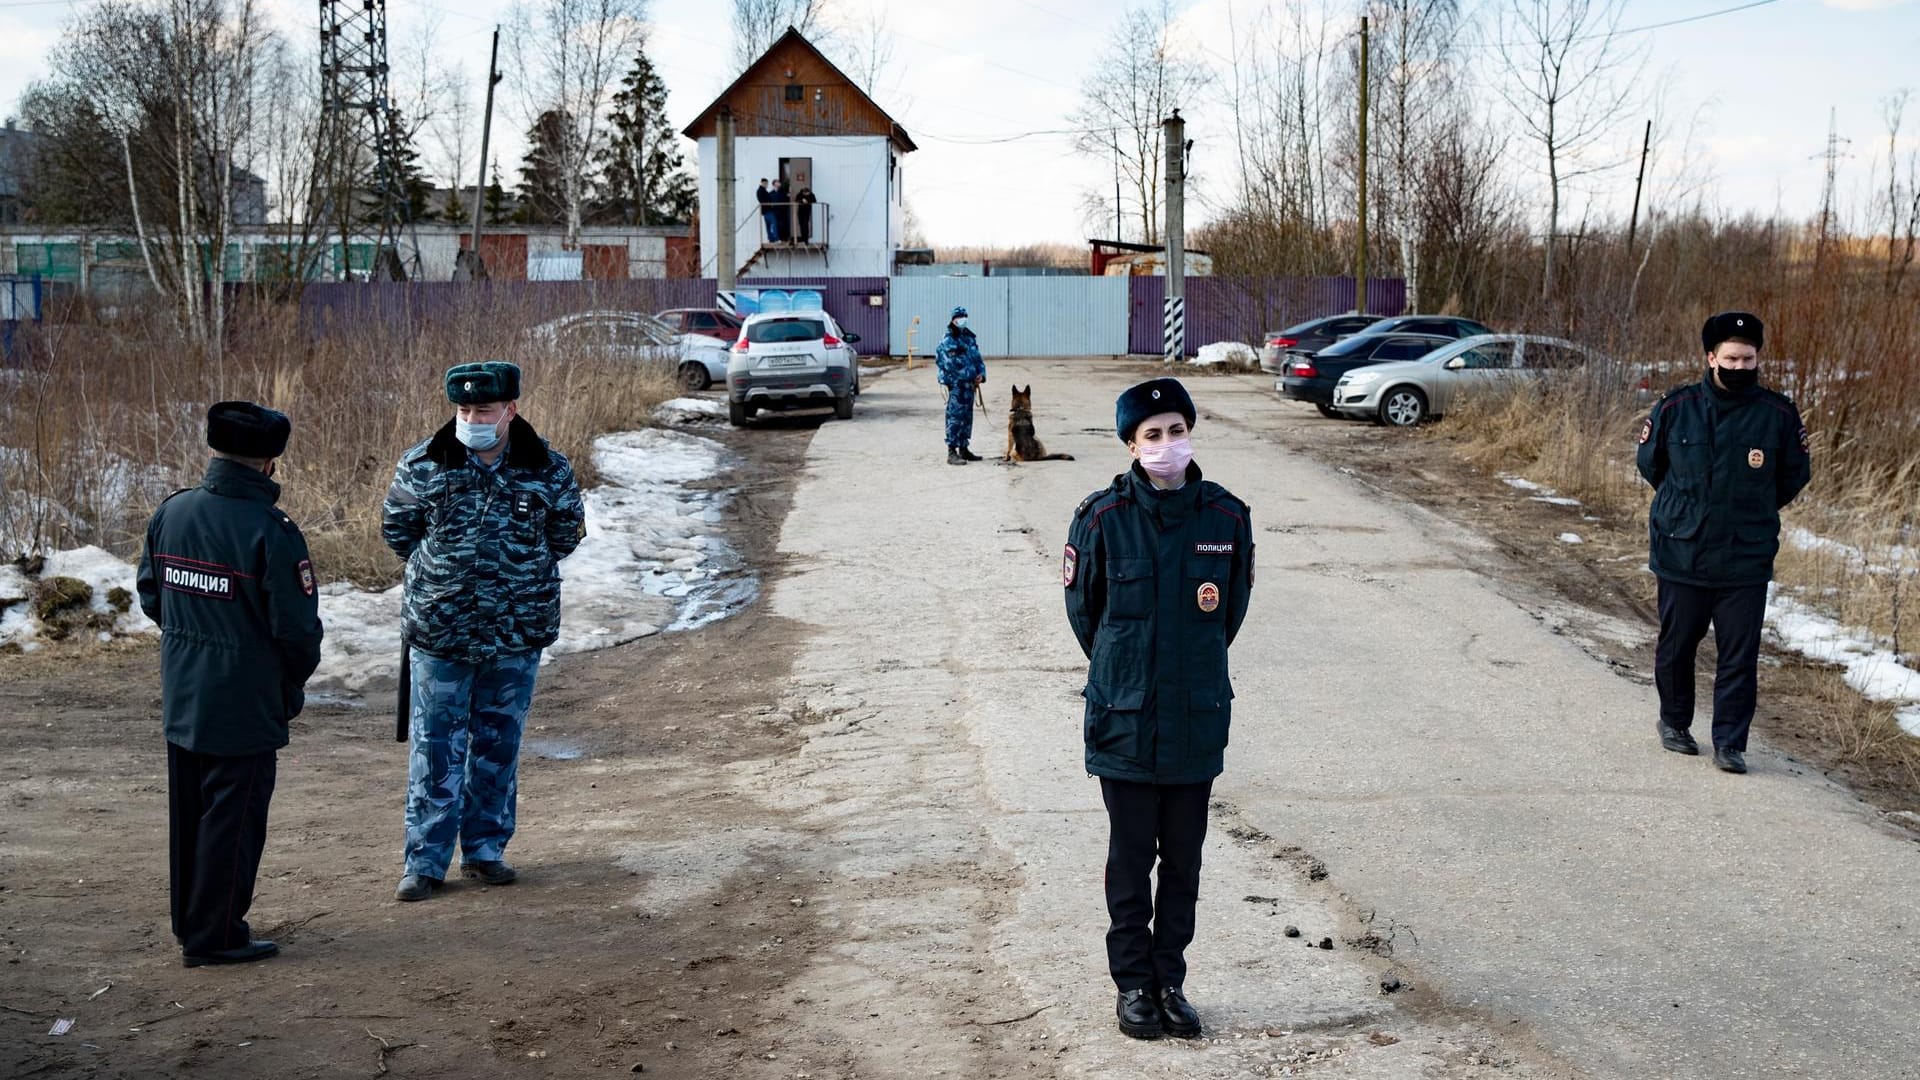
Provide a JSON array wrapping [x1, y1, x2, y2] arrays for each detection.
[[1068, 0, 1213, 244]]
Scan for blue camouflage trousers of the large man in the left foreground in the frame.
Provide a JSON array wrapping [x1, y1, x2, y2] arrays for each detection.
[[405, 650, 540, 880]]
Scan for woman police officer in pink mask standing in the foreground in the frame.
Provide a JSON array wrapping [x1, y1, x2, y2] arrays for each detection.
[[1060, 379, 1254, 1040]]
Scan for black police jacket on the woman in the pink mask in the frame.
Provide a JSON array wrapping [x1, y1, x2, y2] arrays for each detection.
[[1060, 465, 1254, 784]]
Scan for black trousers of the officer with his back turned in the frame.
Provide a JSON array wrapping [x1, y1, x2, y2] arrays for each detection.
[[167, 742, 276, 957]]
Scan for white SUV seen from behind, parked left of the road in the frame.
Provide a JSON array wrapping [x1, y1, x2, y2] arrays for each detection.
[[726, 311, 860, 427]]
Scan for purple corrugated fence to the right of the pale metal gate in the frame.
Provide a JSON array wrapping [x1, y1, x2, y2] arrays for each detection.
[[1127, 277, 1407, 356]]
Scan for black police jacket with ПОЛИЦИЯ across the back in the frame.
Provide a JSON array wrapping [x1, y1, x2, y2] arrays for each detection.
[[138, 457, 321, 757]]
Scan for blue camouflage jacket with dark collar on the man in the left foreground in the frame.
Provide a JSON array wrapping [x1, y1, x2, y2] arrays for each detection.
[[380, 417, 586, 663]]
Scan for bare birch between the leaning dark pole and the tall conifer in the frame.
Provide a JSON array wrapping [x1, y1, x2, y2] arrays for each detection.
[[511, 0, 647, 248]]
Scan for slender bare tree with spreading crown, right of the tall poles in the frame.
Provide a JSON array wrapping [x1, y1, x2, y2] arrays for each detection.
[[1494, 0, 1645, 300]]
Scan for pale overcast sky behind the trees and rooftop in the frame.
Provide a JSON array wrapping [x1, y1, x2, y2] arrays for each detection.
[[0, 0, 1920, 244]]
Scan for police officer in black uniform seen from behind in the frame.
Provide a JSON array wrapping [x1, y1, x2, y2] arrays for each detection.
[[138, 402, 321, 967]]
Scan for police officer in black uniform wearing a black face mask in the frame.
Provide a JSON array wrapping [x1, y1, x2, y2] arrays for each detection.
[[1640, 311, 1812, 773]]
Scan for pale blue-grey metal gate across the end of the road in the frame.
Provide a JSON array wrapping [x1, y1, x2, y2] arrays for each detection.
[[887, 277, 1127, 356]]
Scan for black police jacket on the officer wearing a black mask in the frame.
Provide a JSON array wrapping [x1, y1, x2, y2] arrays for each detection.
[[1640, 373, 1812, 588]]
